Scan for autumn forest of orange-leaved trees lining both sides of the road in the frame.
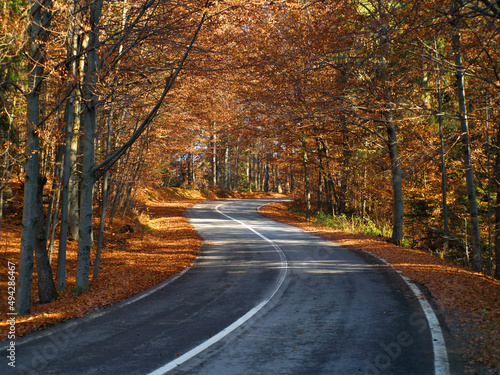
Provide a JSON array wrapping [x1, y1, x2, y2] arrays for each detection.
[[0, 0, 500, 315]]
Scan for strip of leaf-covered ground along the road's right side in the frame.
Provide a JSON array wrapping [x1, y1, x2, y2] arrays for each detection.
[[260, 202, 500, 375]]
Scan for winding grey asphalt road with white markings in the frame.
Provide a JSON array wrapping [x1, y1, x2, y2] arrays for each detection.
[[0, 200, 459, 375]]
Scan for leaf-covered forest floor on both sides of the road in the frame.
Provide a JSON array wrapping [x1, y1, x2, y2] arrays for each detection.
[[0, 189, 500, 374]]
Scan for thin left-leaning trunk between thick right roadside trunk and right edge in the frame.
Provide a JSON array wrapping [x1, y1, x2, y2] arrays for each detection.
[[453, 27, 483, 272]]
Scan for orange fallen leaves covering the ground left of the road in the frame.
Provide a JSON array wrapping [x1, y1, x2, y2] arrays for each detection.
[[0, 200, 201, 340]]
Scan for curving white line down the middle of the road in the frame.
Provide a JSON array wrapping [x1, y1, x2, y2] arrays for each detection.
[[148, 204, 288, 375]]
